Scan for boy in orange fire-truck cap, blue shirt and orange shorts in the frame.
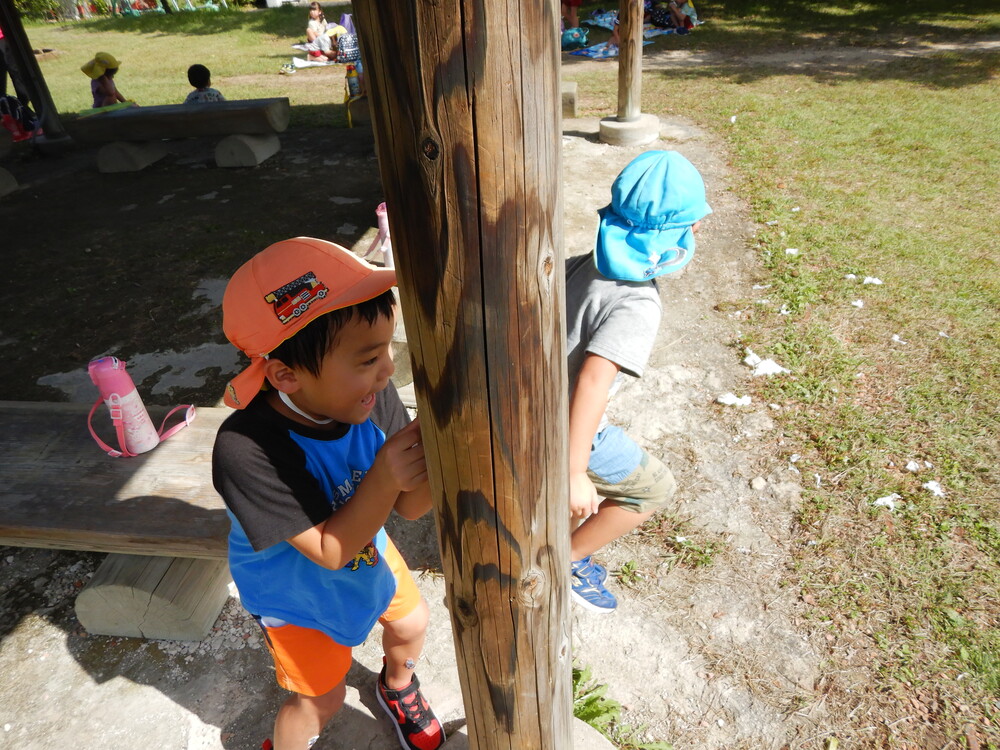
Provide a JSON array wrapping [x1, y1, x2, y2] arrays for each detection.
[[212, 237, 444, 750]]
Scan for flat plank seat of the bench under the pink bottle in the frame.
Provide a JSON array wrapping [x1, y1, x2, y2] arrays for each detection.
[[0, 401, 230, 559]]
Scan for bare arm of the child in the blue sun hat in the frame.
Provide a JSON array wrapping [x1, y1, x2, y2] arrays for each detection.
[[569, 354, 619, 519]]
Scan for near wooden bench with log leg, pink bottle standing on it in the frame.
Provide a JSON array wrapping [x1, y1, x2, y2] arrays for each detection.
[[0, 401, 230, 640]]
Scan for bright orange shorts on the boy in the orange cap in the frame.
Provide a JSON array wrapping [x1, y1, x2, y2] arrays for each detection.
[[261, 537, 421, 696]]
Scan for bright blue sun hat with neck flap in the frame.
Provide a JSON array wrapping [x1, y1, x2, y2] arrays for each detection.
[[594, 151, 712, 281]]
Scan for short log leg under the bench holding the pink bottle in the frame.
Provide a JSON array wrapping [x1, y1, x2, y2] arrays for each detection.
[[76, 555, 230, 641]]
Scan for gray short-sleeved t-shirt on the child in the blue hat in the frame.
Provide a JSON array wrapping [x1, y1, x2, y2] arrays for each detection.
[[566, 255, 662, 432]]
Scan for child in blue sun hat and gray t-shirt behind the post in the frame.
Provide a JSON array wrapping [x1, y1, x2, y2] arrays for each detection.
[[566, 151, 712, 612]]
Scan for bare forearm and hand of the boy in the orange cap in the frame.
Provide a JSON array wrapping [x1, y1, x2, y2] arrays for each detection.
[[288, 422, 427, 570]]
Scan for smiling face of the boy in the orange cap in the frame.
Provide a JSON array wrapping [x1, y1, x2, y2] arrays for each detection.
[[292, 317, 396, 424]]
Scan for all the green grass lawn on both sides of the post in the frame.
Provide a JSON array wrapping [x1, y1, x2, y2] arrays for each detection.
[[13, 0, 1000, 748]]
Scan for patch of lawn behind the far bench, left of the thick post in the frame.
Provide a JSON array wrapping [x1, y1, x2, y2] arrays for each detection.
[[25, 3, 350, 127]]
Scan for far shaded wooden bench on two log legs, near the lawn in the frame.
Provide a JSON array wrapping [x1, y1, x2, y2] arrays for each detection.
[[66, 97, 291, 172]]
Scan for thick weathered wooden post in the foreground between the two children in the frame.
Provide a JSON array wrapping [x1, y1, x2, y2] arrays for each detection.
[[354, 0, 572, 750]]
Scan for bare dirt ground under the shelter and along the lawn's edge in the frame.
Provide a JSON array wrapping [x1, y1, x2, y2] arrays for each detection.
[[0, 39, 968, 750]]
